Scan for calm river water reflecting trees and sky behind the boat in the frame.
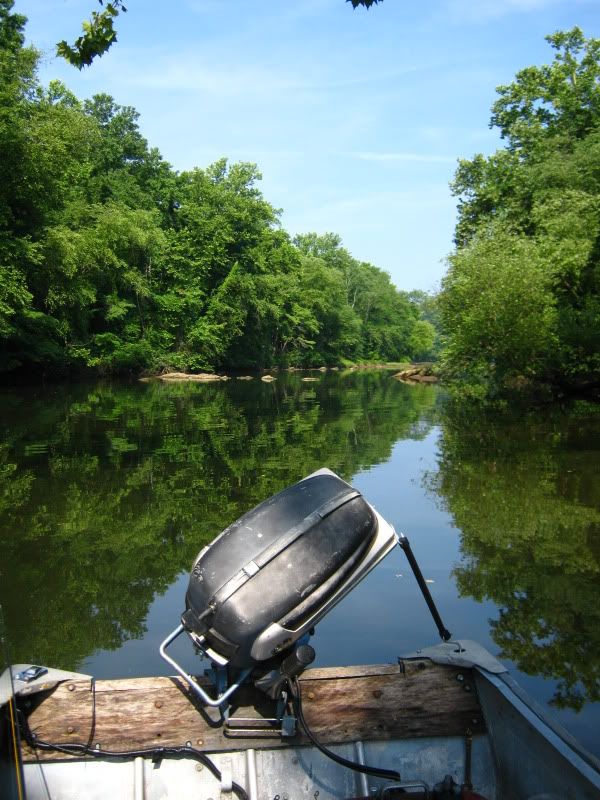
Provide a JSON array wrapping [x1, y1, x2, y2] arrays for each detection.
[[0, 372, 600, 755]]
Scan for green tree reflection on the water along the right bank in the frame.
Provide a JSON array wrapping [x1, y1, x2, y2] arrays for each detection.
[[431, 403, 600, 709]]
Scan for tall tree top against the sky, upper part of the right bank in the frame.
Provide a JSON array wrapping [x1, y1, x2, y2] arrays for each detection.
[[452, 28, 600, 246]]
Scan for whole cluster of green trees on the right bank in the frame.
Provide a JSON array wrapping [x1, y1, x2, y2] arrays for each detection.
[[440, 28, 600, 394]]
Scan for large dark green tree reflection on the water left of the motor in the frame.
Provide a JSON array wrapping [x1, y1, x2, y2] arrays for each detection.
[[0, 372, 436, 669]]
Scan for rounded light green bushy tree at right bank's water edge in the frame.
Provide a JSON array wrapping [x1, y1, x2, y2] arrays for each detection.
[[439, 227, 557, 395]]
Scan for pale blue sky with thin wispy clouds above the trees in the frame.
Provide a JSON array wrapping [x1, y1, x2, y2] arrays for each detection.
[[15, 0, 600, 290]]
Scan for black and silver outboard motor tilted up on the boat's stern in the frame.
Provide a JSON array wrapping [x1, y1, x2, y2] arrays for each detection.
[[160, 469, 398, 707]]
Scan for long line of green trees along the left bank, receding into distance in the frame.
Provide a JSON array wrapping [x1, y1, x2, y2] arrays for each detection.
[[0, 0, 435, 373]]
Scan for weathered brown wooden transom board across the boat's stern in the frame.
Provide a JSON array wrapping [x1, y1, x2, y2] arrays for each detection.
[[19, 659, 485, 762]]
